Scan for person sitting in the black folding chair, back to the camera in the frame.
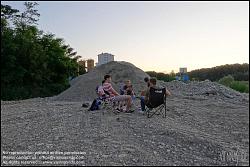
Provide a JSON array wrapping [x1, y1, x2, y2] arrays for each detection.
[[141, 78, 171, 112]]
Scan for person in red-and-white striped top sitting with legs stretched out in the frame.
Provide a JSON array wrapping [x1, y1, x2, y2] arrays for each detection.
[[103, 75, 133, 112]]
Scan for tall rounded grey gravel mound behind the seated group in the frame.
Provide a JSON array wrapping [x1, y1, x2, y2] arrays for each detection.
[[52, 61, 149, 101]]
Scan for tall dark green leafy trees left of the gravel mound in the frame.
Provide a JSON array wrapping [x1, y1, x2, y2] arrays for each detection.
[[1, 2, 85, 100]]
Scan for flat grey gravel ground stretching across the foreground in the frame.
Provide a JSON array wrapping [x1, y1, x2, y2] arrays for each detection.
[[1, 92, 249, 166]]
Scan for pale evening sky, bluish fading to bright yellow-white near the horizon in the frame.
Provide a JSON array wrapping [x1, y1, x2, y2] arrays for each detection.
[[1, 1, 249, 73]]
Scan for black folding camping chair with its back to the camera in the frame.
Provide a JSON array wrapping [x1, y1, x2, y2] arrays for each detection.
[[146, 87, 167, 118]]
